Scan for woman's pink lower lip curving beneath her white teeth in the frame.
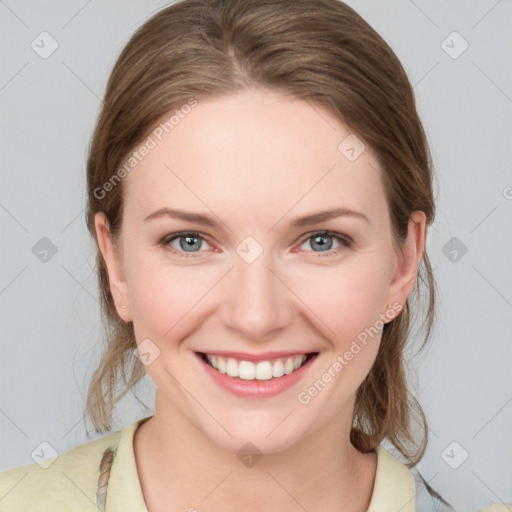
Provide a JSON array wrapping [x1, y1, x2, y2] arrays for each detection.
[[196, 352, 317, 398]]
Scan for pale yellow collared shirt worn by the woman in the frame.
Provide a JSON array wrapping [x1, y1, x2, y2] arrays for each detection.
[[0, 416, 415, 512]]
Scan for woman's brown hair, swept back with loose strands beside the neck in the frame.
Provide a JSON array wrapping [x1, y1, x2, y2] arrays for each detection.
[[86, 0, 435, 467]]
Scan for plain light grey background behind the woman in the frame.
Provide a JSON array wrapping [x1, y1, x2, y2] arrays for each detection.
[[0, 0, 512, 511]]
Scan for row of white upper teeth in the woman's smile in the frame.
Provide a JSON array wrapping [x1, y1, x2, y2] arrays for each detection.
[[206, 354, 307, 380]]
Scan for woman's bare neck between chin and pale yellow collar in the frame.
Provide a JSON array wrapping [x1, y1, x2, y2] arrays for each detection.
[[134, 391, 377, 512]]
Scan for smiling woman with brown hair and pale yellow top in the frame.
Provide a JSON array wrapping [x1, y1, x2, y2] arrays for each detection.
[[0, 0, 450, 512]]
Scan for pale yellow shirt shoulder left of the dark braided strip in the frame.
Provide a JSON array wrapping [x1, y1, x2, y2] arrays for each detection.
[[0, 431, 121, 512]]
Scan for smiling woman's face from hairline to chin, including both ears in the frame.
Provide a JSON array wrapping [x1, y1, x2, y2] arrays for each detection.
[[96, 86, 424, 452]]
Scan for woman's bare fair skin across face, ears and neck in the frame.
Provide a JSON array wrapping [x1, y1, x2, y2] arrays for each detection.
[[96, 89, 425, 512]]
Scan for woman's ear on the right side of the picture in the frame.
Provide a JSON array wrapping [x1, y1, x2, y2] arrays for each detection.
[[386, 210, 427, 318]]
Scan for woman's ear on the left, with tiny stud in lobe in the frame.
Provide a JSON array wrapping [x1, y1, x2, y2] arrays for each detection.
[[94, 212, 132, 322]]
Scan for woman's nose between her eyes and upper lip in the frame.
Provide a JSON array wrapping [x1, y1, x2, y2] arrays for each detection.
[[221, 251, 293, 341]]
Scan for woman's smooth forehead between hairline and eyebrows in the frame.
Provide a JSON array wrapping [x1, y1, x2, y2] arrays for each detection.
[[125, 89, 386, 222]]
